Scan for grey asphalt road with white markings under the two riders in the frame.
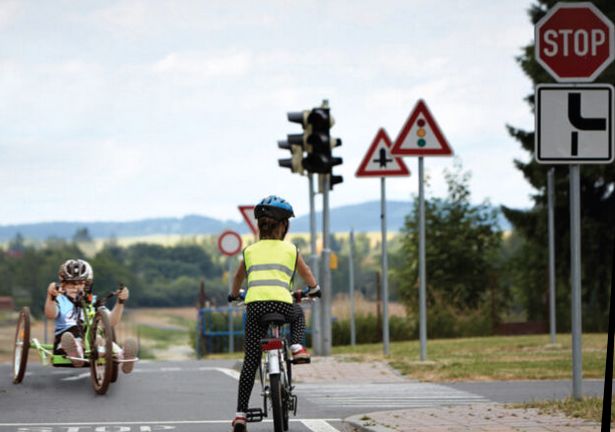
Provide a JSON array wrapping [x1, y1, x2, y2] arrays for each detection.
[[0, 361, 603, 432]]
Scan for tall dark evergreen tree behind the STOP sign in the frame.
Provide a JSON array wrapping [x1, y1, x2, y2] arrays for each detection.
[[502, 0, 615, 330]]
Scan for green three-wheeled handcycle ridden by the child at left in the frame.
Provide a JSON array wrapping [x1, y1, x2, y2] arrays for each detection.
[[13, 284, 139, 394]]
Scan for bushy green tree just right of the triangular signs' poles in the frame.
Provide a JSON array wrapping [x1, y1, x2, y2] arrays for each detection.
[[392, 161, 502, 336]]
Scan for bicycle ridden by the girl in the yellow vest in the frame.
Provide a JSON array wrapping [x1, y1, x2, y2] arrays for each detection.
[[229, 287, 321, 432]]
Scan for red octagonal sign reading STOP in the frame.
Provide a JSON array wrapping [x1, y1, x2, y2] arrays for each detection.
[[535, 2, 615, 82]]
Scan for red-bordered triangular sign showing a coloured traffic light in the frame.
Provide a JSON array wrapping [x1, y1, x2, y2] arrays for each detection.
[[391, 99, 453, 156]]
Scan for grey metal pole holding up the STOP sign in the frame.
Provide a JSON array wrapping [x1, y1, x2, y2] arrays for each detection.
[[570, 165, 583, 400]]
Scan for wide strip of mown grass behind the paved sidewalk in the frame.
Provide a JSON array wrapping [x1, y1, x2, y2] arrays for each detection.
[[333, 334, 607, 382]]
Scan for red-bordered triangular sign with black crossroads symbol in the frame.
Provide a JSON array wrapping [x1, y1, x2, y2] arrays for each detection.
[[355, 129, 410, 177]]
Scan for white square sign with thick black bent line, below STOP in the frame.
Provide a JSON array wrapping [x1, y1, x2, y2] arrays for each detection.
[[535, 84, 615, 164]]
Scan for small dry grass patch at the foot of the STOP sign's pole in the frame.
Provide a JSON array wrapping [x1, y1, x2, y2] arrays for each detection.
[[507, 397, 615, 423]]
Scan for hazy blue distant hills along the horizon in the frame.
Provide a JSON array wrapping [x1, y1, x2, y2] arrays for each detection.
[[0, 201, 510, 242]]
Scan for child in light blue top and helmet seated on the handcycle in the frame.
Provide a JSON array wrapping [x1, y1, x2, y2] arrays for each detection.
[[45, 259, 137, 373]]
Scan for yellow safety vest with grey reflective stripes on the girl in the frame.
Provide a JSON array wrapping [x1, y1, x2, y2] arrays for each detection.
[[243, 240, 298, 303]]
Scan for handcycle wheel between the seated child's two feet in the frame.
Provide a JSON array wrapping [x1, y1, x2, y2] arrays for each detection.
[[89, 309, 113, 394]]
